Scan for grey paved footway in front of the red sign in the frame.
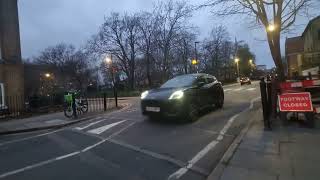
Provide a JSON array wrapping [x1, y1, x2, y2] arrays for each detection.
[[208, 103, 320, 180]]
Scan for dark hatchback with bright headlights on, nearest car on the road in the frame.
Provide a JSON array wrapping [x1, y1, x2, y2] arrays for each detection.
[[141, 73, 224, 121]]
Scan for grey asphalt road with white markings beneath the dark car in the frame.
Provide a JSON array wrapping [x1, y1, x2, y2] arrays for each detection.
[[0, 83, 260, 180]]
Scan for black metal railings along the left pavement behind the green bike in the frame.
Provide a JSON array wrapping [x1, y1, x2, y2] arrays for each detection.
[[0, 94, 115, 119]]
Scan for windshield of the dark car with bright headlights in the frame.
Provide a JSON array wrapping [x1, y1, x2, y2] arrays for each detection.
[[160, 75, 197, 88]]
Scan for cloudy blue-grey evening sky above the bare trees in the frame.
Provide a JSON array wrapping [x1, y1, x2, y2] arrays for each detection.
[[18, 0, 318, 67]]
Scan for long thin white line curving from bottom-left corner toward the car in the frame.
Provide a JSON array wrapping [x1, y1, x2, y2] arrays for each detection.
[[0, 122, 136, 179]]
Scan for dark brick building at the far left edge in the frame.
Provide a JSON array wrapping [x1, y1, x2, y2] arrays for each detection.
[[0, 0, 24, 108]]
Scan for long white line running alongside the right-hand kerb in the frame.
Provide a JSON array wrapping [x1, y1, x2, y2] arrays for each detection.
[[168, 97, 260, 180]]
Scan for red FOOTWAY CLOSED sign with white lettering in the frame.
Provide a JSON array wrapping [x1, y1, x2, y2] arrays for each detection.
[[278, 92, 313, 112]]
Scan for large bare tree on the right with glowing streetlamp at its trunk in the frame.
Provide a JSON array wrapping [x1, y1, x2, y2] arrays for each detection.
[[204, 0, 315, 80]]
